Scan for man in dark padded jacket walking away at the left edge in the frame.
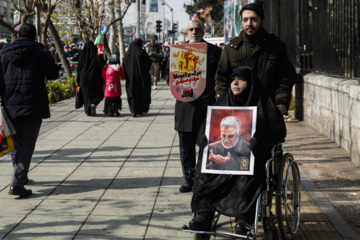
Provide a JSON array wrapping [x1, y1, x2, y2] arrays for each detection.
[[0, 23, 59, 197]]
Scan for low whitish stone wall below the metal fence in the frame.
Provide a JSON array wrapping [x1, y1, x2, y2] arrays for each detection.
[[294, 73, 360, 167]]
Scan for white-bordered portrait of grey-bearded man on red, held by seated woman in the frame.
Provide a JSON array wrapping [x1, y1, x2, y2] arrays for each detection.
[[201, 106, 257, 175]]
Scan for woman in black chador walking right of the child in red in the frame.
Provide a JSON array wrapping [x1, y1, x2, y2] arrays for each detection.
[[124, 38, 152, 117]]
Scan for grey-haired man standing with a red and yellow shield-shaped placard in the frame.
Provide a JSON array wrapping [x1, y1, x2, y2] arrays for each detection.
[[170, 20, 221, 192]]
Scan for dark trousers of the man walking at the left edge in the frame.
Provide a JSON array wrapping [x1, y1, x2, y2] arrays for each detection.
[[11, 118, 42, 187]]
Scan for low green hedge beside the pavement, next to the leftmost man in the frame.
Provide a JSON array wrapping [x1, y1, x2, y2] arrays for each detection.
[[47, 76, 76, 104]]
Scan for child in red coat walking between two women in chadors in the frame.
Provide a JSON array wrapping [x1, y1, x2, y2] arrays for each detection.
[[102, 54, 125, 116]]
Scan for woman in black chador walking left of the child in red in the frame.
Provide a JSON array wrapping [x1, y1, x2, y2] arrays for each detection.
[[77, 41, 106, 116]]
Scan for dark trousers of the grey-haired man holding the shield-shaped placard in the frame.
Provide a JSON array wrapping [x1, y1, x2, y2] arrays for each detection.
[[178, 131, 197, 181]]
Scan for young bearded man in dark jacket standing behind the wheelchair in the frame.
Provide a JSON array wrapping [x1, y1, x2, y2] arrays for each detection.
[[215, 3, 296, 114]]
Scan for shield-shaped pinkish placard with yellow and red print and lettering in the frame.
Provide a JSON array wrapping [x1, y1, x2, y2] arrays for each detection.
[[169, 43, 207, 102]]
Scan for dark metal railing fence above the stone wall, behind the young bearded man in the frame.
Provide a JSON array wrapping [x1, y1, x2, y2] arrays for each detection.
[[259, 0, 360, 80]]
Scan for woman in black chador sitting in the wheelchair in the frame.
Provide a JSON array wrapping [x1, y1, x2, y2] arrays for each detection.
[[189, 67, 286, 235]]
